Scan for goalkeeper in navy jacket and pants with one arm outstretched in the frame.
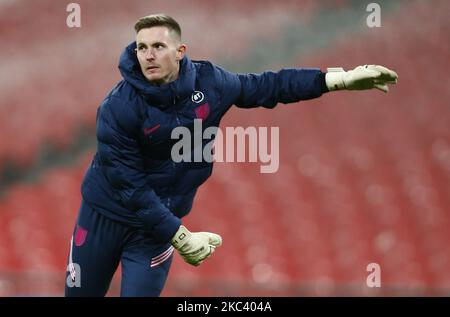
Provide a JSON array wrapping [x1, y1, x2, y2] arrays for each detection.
[[65, 14, 397, 296]]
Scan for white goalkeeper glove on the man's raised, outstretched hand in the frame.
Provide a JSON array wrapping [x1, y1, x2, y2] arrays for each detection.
[[325, 65, 398, 92]]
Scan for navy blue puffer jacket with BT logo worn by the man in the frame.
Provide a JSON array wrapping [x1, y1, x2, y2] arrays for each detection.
[[82, 43, 326, 242]]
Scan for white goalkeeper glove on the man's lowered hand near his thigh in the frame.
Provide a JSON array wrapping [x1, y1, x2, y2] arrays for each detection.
[[172, 226, 222, 266]]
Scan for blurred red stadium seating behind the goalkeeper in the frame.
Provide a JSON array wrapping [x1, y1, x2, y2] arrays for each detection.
[[0, 0, 450, 296]]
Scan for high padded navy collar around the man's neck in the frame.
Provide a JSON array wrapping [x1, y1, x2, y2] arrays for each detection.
[[119, 42, 196, 108]]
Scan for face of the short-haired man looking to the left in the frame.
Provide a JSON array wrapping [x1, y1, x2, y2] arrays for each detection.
[[136, 26, 186, 85]]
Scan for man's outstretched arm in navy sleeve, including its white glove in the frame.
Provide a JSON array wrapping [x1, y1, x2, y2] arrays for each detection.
[[216, 65, 398, 108]]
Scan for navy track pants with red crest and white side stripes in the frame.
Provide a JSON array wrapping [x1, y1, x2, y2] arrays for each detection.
[[65, 202, 174, 297]]
